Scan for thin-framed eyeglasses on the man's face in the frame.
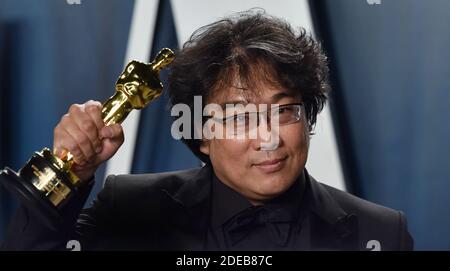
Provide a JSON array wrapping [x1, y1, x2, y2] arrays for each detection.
[[209, 103, 303, 135]]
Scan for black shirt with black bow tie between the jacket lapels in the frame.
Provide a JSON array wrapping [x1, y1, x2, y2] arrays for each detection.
[[206, 174, 305, 250]]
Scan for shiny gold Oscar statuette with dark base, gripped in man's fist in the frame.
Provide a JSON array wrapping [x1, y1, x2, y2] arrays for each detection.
[[0, 48, 175, 227]]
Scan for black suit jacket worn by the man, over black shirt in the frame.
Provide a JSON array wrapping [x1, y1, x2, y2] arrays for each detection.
[[2, 165, 413, 253]]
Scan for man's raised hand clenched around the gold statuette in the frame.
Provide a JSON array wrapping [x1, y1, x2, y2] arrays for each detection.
[[53, 101, 124, 181]]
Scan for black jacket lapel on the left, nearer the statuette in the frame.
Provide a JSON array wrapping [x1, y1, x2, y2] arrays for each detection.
[[159, 165, 212, 250]]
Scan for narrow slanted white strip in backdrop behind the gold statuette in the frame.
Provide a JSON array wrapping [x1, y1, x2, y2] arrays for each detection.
[[105, 0, 159, 177]]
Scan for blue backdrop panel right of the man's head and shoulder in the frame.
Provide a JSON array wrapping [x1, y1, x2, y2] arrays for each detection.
[[310, 0, 450, 249]]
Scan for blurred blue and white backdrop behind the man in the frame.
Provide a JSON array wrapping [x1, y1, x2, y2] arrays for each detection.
[[0, 0, 450, 250]]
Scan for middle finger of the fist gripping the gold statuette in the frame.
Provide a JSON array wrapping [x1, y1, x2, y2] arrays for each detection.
[[69, 105, 102, 153]]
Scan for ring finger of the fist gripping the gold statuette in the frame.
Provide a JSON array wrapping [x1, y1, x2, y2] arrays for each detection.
[[61, 113, 95, 165]]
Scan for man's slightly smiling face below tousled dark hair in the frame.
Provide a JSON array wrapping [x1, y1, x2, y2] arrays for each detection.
[[200, 84, 309, 205]]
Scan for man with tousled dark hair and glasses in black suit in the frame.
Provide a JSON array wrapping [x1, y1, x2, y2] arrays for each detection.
[[4, 11, 413, 253]]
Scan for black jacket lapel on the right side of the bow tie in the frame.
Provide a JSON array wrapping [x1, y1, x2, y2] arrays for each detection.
[[305, 173, 358, 250]]
